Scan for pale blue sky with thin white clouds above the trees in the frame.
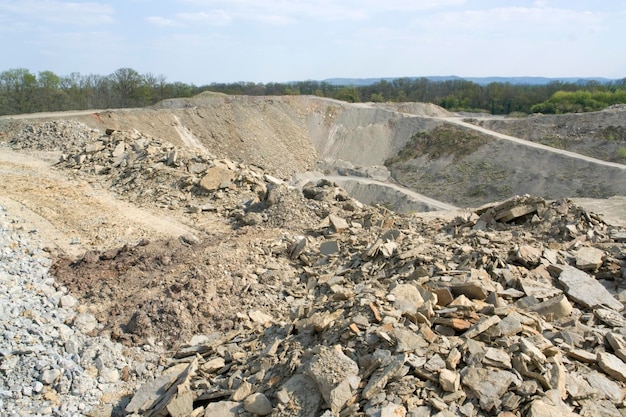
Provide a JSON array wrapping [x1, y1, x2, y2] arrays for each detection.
[[0, 0, 626, 85]]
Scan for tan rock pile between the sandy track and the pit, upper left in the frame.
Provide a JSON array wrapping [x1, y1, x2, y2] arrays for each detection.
[[53, 125, 282, 221]]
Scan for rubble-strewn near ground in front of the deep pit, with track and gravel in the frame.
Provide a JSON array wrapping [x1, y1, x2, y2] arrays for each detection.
[[0, 98, 626, 417]]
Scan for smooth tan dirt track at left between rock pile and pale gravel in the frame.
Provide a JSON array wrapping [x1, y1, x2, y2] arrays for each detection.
[[0, 147, 202, 256]]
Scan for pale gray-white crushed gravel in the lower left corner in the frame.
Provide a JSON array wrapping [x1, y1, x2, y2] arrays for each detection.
[[0, 206, 161, 417]]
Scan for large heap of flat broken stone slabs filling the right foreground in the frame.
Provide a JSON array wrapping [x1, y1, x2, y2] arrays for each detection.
[[126, 193, 626, 417]]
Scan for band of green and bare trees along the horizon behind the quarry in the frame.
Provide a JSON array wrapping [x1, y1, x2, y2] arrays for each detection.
[[0, 68, 626, 115]]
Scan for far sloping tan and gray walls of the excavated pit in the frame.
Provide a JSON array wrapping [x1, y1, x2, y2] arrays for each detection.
[[0, 92, 626, 211]]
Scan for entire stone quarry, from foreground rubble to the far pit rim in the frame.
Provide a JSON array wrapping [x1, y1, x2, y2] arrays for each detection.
[[0, 92, 626, 417]]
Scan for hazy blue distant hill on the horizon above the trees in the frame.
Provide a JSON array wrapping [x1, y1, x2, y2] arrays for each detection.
[[323, 75, 617, 87]]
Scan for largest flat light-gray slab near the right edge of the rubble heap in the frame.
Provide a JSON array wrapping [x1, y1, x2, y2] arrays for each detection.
[[558, 265, 624, 311]]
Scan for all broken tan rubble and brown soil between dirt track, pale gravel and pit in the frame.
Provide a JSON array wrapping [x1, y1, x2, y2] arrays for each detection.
[[6, 118, 626, 417]]
